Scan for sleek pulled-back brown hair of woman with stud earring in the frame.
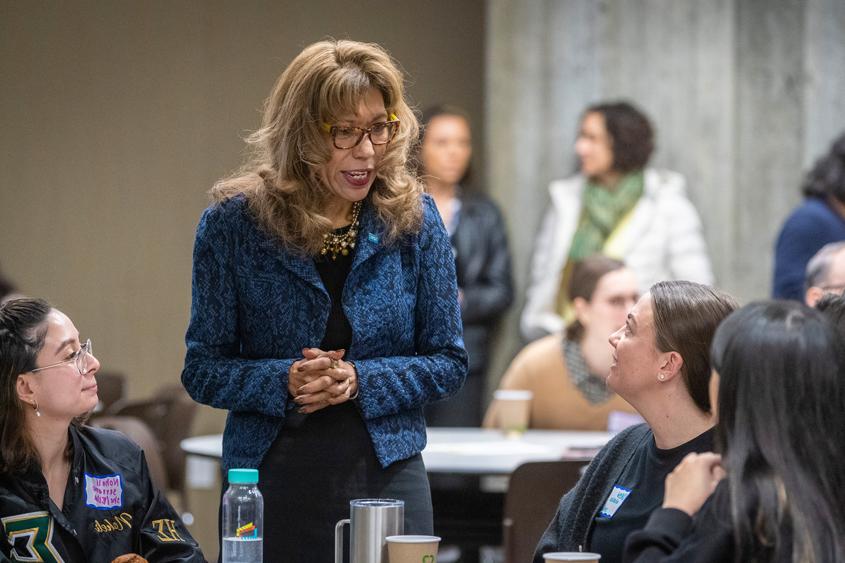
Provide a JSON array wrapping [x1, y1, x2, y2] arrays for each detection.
[[649, 281, 739, 412]]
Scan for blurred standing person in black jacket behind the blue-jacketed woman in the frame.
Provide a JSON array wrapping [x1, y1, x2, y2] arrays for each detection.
[[420, 106, 513, 426]]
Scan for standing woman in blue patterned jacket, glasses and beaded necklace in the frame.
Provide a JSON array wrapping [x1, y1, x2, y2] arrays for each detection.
[[182, 41, 466, 562]]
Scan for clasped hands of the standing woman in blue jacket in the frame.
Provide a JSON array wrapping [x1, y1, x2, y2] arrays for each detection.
[[288, 348, 358, 414]]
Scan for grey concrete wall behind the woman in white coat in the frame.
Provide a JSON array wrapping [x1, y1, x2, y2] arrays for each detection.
[[487, 0, 845, 383]]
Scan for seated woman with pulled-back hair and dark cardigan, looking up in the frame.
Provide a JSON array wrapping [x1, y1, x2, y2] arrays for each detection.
[[534, 281, 736, 563]]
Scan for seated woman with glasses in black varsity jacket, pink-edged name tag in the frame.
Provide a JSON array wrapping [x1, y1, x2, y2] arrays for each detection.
[[0, 299, 205, 562]]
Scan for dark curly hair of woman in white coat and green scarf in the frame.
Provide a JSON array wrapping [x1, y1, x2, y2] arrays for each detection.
[[584, 101, 654, 173]]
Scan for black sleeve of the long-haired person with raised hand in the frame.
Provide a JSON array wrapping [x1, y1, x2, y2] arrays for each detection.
[[622, 497, 733, 563]]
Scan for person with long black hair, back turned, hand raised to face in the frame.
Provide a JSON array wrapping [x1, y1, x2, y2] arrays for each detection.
[[624, 304, 845, 563]]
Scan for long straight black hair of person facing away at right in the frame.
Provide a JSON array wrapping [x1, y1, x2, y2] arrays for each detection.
[[712, 301, 845, 562]]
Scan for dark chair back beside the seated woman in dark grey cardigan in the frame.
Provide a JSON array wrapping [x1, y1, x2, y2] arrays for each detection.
[[502, 460, 588, 563]]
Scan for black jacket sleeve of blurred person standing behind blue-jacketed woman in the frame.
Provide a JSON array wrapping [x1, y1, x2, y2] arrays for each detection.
[[461, 203, 513, 324]]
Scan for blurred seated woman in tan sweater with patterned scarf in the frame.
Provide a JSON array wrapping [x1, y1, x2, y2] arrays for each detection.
[[484, 255, 639, 430]]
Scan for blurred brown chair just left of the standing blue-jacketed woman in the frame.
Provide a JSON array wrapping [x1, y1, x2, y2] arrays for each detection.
[[106, 385, 197, 513]]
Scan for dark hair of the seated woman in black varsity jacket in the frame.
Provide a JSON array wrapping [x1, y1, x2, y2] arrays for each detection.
[[0, 299, 52, 475]]
